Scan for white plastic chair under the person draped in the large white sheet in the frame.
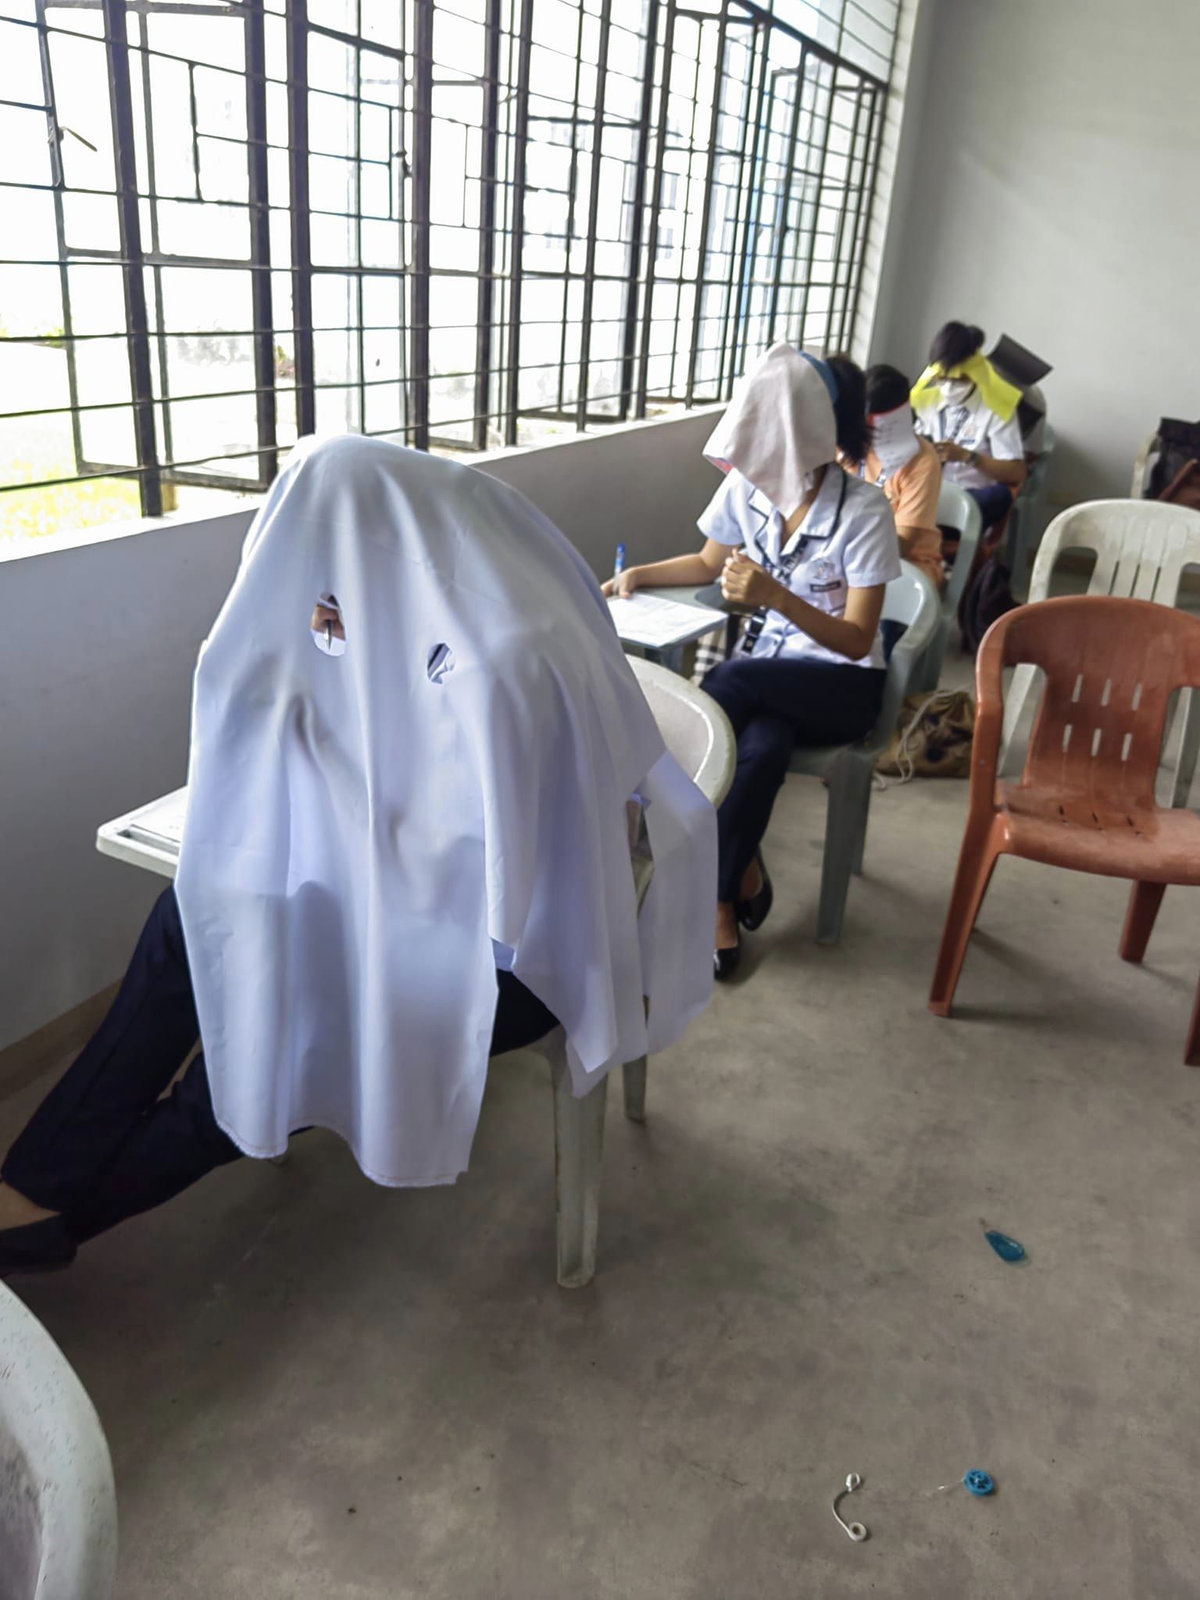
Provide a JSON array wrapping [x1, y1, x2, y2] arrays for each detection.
[[531, 656, 736, 1290]]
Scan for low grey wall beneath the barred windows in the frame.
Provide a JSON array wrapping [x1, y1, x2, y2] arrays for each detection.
[[0, 413, 718, 1048]]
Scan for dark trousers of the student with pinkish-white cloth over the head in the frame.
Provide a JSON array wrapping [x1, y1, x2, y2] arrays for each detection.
[[704, 656, 886, 902]]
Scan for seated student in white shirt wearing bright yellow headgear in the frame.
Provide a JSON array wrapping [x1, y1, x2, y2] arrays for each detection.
[[912, 322, 1026, 531]]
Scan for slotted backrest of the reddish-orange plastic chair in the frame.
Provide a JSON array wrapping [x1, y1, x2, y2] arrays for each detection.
[[976, 595, 1200, 806]]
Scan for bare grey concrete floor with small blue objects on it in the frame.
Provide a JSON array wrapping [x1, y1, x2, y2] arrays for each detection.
[[0, 732, 1200, 1600]]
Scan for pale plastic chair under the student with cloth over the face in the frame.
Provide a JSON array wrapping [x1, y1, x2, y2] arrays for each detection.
[[789, 562, 941, 944]]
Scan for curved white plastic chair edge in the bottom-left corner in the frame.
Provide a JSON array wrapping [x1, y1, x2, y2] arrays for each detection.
[[0, 1283, 117, 1600]]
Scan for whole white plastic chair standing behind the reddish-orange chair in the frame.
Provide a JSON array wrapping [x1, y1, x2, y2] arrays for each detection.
[[997, 499, 1200, 805]]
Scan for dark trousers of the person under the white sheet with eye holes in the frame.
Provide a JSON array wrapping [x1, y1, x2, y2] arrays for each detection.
[[0, 890, 555, 1243]]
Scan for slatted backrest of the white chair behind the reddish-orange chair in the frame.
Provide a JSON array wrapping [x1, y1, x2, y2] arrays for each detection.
[[1029, 499, 1200, 606]]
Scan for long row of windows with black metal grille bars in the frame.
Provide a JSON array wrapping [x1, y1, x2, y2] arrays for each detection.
[[0, 0, 899, 517]]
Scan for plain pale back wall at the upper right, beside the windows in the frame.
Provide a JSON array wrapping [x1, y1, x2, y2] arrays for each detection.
[[872, 0, 1200, 504]]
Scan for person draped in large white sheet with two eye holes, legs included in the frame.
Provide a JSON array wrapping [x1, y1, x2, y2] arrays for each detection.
[[0, 438, 717, 1272]]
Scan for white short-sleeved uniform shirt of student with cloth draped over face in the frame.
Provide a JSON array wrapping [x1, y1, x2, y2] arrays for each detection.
[[699, 461, 901, 667]]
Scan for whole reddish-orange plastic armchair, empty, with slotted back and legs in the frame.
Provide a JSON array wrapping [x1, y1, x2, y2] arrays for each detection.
[[930, 595, 1200, 1066]]
